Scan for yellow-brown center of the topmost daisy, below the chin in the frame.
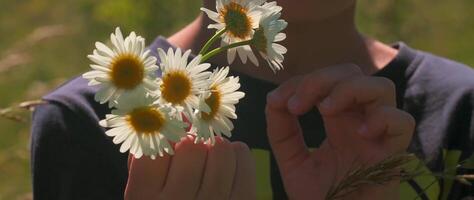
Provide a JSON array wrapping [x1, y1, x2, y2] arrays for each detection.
[[220, 2, 252, 40]]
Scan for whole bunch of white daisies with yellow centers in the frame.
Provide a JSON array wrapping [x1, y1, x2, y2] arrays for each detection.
[[82, 0, 287, 159]]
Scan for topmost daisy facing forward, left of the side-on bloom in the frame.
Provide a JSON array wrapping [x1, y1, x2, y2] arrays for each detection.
[[201, 0, 265, 64]]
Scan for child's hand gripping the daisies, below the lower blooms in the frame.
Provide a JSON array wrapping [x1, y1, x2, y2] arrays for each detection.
[[125, 138, 256, 200]]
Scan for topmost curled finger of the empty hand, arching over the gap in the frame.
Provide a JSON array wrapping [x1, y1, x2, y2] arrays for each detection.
[[288, 64, 363, 115]]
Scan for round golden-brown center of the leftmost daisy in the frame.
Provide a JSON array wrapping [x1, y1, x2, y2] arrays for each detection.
[[109, 54, 145, 90]]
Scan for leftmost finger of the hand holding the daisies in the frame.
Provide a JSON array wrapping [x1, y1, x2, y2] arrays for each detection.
[[125, 155, 170, 200]]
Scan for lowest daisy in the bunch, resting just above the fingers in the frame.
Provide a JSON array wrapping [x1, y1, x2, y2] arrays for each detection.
[[99, 92, 186, 159]]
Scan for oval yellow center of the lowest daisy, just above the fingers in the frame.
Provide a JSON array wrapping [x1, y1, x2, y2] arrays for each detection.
[[127, 107, 165, 134]]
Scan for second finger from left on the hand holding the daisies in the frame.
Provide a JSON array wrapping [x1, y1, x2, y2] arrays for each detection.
[[160, 137, 207, 200]]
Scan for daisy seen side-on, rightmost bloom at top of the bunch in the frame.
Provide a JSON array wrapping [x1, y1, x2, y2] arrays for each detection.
[[252, 2, 288, 72]]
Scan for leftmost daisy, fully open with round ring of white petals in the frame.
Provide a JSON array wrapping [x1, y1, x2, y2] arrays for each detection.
[[82, 27, 158, 107]]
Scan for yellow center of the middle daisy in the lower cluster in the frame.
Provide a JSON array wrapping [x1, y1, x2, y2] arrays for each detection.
[[161, 71, 192, 105]]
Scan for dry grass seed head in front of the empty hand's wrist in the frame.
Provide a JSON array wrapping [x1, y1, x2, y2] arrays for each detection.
[[326, 153, 418, 200]]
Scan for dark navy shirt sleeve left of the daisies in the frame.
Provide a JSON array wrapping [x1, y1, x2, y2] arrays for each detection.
[[31, 101, 128, 200]]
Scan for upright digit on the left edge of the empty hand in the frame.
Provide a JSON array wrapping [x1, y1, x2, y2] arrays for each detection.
[[266, 76, 309, 174]]
